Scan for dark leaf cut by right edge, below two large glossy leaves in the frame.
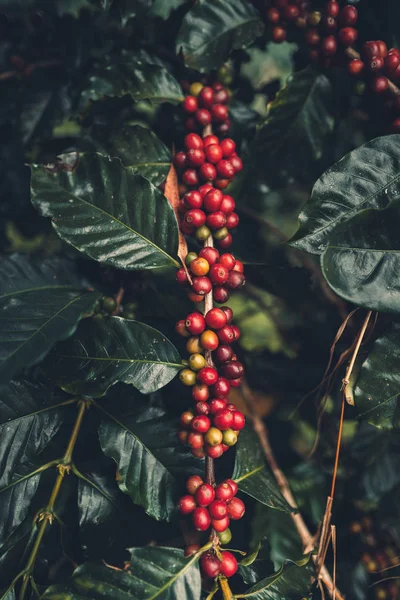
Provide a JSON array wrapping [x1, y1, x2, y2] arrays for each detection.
[[354, 322, 400, 429]]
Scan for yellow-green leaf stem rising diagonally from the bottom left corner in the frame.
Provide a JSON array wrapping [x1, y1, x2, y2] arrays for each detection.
[[18, 399, 90, 600]]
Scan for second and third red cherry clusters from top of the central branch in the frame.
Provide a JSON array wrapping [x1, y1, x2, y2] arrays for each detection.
[[174, 133, 243, 248]]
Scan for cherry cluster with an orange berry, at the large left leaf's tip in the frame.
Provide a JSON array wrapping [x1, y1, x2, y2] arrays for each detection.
[[176, 246, 245, 304]]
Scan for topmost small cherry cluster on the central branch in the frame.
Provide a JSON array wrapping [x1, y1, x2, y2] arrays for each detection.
[[182, 81, 231, 135]]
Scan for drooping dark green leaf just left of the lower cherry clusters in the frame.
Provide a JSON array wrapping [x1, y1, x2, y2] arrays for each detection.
[[99, 392, 201, 520]]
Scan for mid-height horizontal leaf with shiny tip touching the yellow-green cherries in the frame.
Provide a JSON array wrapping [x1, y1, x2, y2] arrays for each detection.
[[43, 317, 182, 398]]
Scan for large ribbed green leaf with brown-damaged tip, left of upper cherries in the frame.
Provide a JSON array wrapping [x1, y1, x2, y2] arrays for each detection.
[[31, 153, 179, 270]]
